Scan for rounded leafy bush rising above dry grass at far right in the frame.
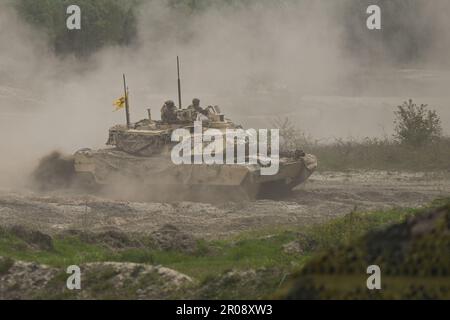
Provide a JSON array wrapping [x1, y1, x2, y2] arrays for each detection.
[[394, 99, 442, 146]]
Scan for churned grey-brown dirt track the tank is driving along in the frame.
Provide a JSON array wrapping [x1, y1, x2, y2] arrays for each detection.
[[0, 171, 450, 238]]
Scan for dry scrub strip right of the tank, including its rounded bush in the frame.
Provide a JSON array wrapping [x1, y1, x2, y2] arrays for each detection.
[[280, 100, 450, 171]]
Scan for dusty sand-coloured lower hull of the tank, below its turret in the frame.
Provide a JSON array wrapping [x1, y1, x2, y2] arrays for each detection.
[[74, 149, 317, 201]]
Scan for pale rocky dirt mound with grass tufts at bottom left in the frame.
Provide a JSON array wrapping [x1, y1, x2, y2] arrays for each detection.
[[0, 257, 194, 300]]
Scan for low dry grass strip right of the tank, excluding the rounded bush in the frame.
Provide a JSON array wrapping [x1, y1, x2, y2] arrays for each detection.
[[272, 114, 450, 171]]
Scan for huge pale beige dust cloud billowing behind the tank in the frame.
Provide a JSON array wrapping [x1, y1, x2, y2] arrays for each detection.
[[0, 0, 450, 186]]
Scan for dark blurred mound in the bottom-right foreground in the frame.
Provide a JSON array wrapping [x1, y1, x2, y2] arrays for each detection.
[[279, 202, 450, 299]]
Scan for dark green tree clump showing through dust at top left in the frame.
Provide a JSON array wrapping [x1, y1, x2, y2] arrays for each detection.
[[15, 0, 139, 56]]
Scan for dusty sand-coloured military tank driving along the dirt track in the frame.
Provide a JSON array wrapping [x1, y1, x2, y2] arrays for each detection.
[[70, 100, 317, 201]]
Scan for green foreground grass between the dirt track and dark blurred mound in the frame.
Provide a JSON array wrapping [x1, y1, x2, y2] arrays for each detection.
[[0, 199, 442, 299]]
